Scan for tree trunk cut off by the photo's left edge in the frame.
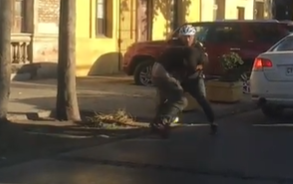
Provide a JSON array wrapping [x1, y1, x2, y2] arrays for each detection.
[[0, 0, 12, 123]]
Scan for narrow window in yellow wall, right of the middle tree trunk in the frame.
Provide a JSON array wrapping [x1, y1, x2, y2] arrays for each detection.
[[96, 0, 108, 36]]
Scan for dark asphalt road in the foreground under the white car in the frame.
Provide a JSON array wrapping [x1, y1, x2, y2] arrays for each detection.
[[0, 111, 293, 184]]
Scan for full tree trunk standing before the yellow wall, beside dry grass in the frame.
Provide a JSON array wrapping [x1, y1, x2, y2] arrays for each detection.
[[56, 0, 80, 121]]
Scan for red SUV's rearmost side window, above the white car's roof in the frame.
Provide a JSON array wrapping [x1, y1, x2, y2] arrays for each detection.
[[249, 23, 289, 43]]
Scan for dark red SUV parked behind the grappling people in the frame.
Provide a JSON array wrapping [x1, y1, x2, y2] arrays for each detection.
[[123, 20, 289, 86]]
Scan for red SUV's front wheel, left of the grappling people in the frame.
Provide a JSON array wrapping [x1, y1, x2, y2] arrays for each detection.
[[134, 61, 154, 86]]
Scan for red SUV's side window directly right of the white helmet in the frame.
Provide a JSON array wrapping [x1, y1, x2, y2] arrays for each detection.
[[206, 25, 242, 43]]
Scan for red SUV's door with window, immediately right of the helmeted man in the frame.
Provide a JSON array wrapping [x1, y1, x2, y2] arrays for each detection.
[[202, 23, 243, 75]]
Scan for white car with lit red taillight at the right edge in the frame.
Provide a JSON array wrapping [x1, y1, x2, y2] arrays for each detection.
[[250, 33, 293, 117]]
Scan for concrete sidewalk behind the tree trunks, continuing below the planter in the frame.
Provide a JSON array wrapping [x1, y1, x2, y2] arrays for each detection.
[[9, 77, 255, 119]]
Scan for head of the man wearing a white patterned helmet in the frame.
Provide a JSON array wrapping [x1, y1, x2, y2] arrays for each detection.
[[179, 25, 196, 46]]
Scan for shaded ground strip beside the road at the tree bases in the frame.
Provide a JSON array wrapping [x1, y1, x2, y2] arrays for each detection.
[[0, 121, 146, 167]]
